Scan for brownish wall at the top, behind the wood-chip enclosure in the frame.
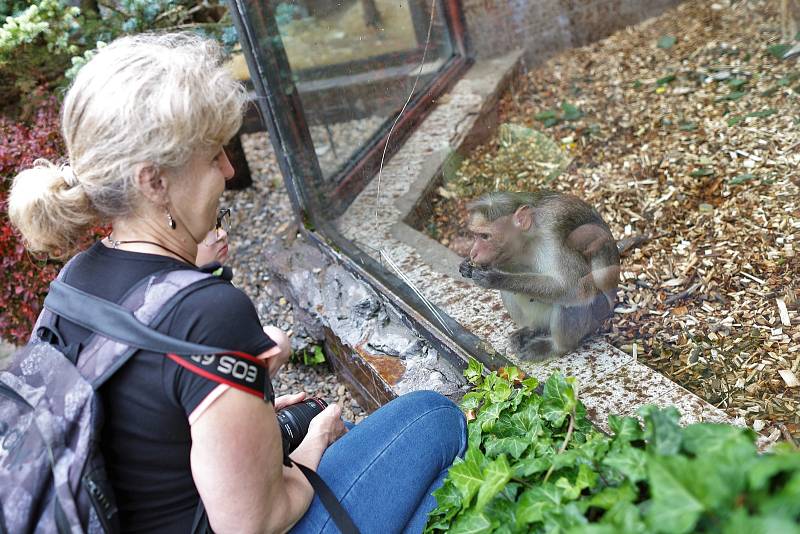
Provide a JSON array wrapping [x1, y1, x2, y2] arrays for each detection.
[[462, 0, 680, 66]]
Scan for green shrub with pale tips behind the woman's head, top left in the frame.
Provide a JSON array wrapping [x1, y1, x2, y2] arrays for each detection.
[[0, 0, 237, 117]]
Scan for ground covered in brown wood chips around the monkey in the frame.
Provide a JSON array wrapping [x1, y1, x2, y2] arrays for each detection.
[[432, 0, 800, 441]]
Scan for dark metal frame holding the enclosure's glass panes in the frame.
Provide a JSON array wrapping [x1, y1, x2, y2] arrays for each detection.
[[229, 0, 509, 369]]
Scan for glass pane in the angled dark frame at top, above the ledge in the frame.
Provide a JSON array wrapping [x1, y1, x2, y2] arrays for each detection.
[[271, 0, 452, 181]]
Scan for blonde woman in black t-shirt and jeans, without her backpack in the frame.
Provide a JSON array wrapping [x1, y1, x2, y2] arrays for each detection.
[[9, 31, 466, 533]]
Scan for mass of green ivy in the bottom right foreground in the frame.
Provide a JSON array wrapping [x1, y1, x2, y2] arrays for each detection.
[[426, 361, 800, 534]]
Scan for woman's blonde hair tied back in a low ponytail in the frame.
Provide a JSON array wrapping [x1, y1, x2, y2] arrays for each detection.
[[8, 34, 246, 257]]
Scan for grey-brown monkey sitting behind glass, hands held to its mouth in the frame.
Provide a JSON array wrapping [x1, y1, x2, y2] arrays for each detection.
[[459, 190, 620, 361]]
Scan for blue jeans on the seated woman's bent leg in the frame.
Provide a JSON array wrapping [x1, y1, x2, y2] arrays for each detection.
[[291, 391, 467, 534]]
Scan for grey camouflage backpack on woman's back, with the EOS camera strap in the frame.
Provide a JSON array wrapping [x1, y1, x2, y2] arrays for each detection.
[[0, 264, 272, 534]]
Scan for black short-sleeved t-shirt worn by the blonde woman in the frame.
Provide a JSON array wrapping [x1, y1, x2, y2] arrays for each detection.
[[56, 242, 275, 533]]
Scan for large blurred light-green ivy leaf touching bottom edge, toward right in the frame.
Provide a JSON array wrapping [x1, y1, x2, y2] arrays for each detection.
[[646, 456, 703, 534]]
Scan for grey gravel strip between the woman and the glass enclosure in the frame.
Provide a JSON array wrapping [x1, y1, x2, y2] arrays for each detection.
[[222, 132, 366, 422]]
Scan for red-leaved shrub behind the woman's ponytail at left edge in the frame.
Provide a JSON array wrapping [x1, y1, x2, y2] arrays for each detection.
[[0, 99, 104, 344]]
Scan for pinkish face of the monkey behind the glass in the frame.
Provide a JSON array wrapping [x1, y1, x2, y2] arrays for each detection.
[[468, 214, 523, 266]]
